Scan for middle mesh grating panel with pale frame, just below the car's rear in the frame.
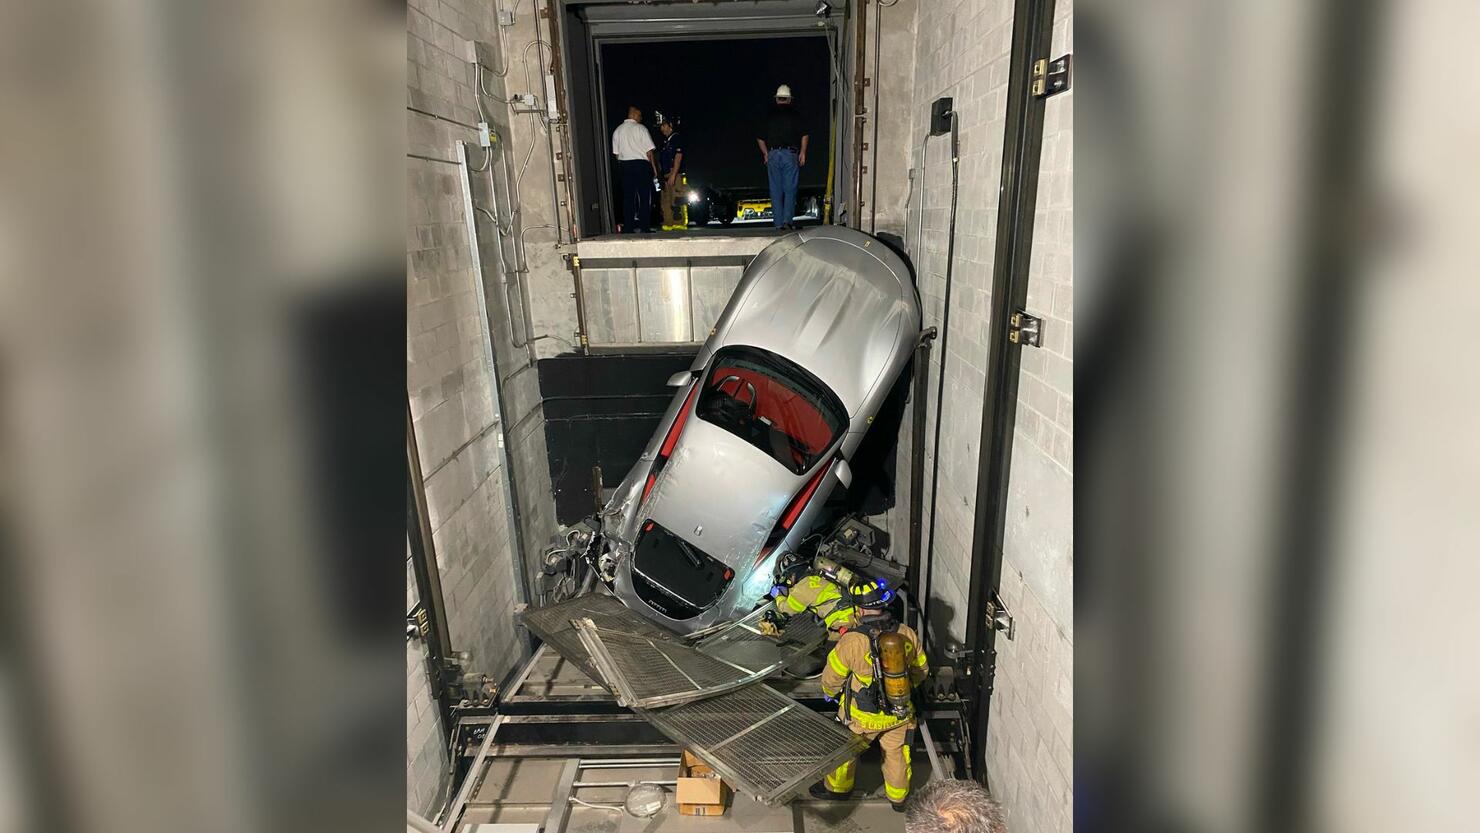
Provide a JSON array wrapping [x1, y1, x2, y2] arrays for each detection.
[[576, 618, 778, 709]]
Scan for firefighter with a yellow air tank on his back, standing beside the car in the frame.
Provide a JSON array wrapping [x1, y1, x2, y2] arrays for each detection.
[[808, 581, 929, 812]]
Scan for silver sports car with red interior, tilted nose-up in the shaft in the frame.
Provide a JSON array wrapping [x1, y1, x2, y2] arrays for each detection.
[[598, 226, 921, 633]]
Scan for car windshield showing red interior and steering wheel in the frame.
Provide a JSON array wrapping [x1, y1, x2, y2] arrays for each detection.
[[696, 348, 848, 475]]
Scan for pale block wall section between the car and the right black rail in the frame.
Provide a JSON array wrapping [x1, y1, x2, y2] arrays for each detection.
[[900, 0, 1012, 641]]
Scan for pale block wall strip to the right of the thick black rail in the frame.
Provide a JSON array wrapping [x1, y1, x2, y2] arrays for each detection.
[[987, 9, 1074, 833]]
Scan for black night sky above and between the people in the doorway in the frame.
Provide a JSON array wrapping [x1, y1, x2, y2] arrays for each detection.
[[601, 37, 829, 194]]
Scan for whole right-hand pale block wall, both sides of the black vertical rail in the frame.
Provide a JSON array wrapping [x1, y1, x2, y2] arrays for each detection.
[[900, 0, 1073, 833]]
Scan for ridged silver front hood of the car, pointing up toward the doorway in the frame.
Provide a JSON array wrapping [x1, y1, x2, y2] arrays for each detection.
[[713, 229, 919, 416]]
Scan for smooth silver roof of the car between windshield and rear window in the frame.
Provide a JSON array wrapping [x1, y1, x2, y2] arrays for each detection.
[[635, 416, 810, 573]]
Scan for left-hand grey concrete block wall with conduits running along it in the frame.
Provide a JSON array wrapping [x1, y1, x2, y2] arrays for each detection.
[[407, 0, 554, 799]]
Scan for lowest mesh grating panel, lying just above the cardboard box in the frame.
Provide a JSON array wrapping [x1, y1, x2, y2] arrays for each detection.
[[642, 685, 867, 805]]
